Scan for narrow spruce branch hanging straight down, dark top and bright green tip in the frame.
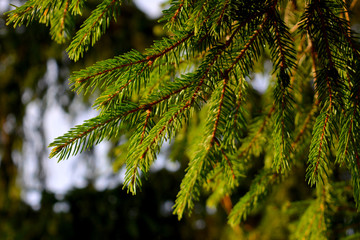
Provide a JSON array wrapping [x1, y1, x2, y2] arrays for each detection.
[[268, 7, 295, 172]]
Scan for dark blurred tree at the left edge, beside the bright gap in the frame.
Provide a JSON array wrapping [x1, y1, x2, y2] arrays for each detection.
[[0, 5, 54, 209]]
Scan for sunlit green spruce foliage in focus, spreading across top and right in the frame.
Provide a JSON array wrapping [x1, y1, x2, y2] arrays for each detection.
[[8, 0, 360, 239]]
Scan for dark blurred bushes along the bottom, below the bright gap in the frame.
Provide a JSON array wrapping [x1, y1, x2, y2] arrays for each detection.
[[0, 170, 231, 240]]
